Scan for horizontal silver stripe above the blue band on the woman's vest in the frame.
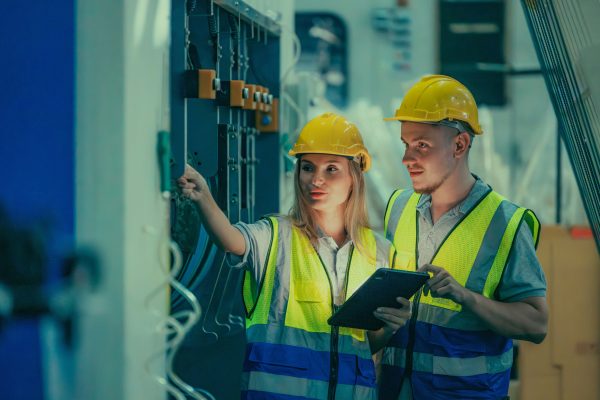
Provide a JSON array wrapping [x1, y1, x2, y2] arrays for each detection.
[[246, 324, 371, 360]]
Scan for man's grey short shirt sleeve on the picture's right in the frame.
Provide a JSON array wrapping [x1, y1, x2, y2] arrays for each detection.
[[497, 223, 546, 303]]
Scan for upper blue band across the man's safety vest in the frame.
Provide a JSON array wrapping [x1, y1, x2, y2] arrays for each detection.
[[388, 321, 512, 358]]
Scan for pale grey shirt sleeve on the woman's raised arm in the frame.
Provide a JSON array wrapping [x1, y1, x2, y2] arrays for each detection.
[[227, 219, 273, 282]]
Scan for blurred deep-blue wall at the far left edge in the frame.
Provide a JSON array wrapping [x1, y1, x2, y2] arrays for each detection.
[[0, 0, 75, 400]]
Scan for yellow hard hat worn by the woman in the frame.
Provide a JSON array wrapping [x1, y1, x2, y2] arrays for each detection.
[[288, 113, 371, 172]]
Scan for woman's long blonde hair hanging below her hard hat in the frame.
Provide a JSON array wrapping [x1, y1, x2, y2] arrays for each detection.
[[289, 159, 375, 258]]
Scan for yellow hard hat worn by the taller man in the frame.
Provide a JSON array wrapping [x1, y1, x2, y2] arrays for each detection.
[[384, 75, 483, 135]]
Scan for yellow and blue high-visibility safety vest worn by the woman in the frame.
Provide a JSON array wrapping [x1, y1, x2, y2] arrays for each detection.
[[242, 217, 384, 400]]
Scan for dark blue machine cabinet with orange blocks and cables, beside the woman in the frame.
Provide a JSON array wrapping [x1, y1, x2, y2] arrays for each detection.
[[171, 0, 281, 399]]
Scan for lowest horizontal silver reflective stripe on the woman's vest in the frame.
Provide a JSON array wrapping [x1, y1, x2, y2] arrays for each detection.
[[242, 372, 376, 400]]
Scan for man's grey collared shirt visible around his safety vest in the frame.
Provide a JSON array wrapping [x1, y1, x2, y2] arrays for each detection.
[[417, 177, 546, 302]]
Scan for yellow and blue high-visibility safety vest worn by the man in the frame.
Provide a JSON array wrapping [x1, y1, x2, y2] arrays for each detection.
[[379, 189, 540, 400]]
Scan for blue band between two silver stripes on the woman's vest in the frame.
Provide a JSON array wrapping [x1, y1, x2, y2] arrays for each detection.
[[244, 343, 376, 387]]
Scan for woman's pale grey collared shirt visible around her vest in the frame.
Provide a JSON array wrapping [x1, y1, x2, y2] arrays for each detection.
[[229, 218, 392, 305]]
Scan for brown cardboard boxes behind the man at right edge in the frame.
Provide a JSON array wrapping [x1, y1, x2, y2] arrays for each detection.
[[518, 226, 600, 400]]
